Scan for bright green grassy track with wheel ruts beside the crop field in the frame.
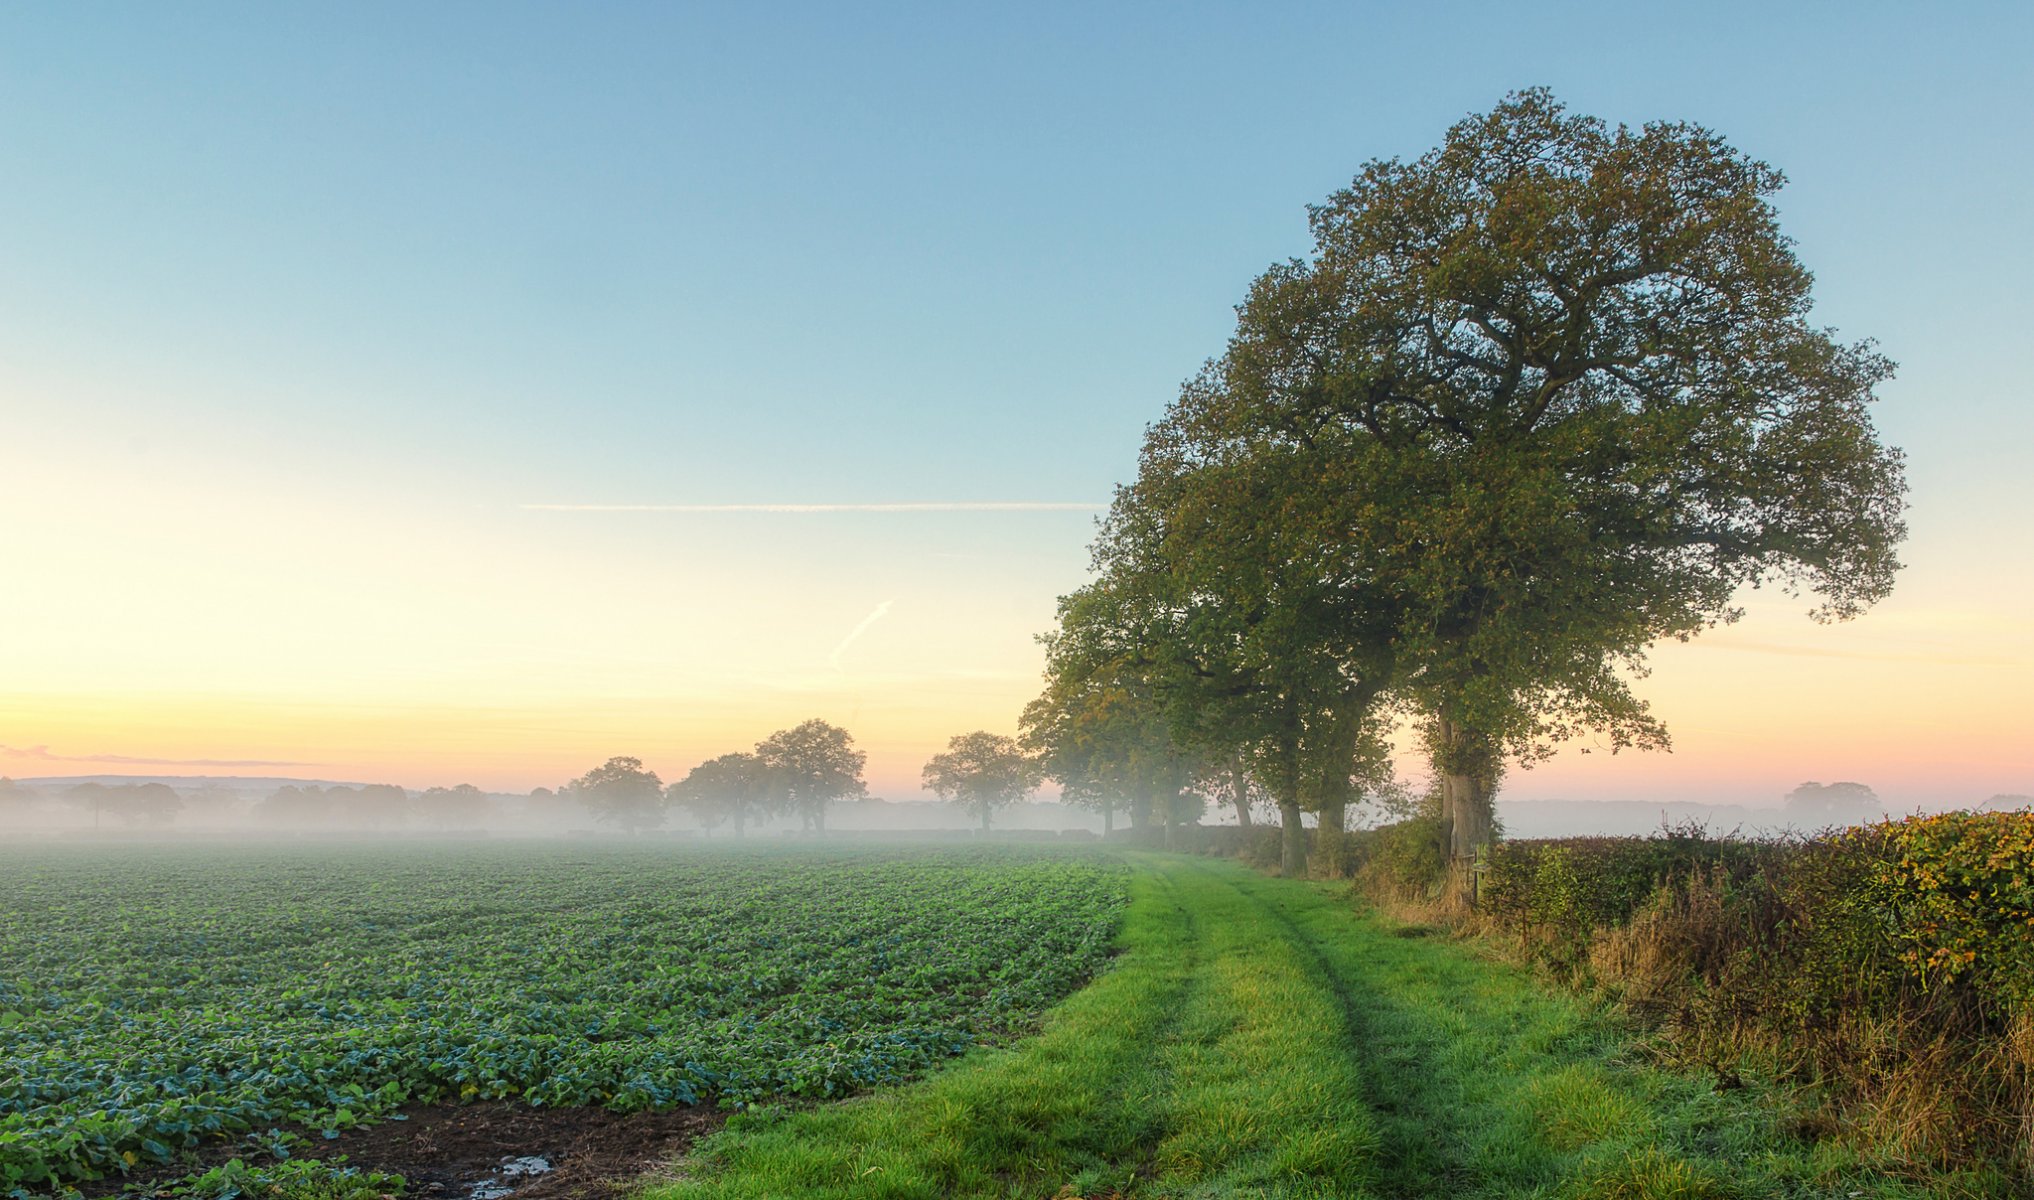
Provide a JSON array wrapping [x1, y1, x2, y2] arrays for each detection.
[[649, 856, 1993, 1200]]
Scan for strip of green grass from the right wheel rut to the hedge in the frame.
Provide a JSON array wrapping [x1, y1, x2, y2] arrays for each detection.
[[1241, 877, 1932, 1200]]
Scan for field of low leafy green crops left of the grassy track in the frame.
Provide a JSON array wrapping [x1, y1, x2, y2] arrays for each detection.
[[0, 844, 1127, 1196]]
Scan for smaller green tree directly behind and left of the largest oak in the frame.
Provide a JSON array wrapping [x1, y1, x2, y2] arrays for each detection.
[[1090, 421, 1397, 877]]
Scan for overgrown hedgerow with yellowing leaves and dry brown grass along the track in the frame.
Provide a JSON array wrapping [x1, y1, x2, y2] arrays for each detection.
[[1367, 812, 2034, 1169]]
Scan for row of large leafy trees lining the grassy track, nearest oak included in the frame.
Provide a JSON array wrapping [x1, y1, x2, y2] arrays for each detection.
[[1023, 92, 1906, 873]]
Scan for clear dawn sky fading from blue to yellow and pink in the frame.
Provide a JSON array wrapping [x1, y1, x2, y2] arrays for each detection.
[[0, 2, 2034, 805]]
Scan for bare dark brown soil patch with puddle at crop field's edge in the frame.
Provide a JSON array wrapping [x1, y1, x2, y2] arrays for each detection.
[[317, 1102, 726, 1200]]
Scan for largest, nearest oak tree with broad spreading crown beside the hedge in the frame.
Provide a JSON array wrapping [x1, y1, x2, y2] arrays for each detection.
[[1176, 92, 1906, 858]]
